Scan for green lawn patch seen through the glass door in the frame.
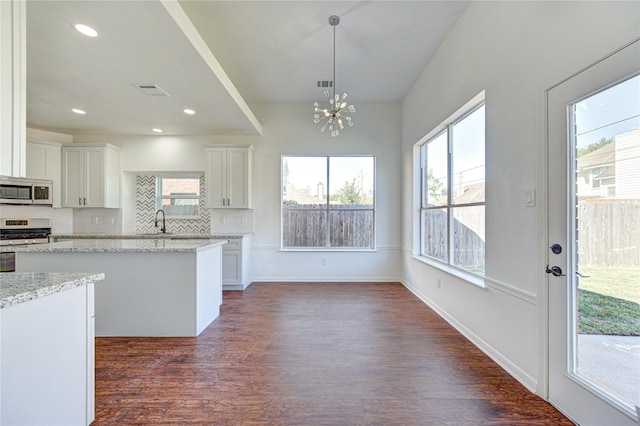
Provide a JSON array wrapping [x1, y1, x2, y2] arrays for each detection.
[[578, 267, 640, 336]]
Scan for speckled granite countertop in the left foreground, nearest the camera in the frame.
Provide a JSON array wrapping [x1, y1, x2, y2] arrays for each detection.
[[0, 272, 104, 309]]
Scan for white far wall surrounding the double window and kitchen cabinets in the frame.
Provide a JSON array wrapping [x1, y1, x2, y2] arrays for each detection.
[[74, 100, 401, 281]]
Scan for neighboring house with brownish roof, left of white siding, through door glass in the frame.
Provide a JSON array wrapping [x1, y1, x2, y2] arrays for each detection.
[[576, 138, 617, 199]]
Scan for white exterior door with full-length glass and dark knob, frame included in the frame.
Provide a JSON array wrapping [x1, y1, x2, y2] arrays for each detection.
[[546, 41, 640, 425]]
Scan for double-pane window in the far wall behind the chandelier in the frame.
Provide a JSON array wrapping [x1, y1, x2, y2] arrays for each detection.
[[282, 156, 375, 249]]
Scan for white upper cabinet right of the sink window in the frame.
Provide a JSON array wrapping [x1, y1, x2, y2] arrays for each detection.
[[205, 145, 253, 209]]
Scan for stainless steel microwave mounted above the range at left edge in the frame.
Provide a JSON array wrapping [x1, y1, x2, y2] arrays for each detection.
[[0, 176, 53, 206]]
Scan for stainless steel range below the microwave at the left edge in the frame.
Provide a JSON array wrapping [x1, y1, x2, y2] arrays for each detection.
[[0, 218, 51, 272]]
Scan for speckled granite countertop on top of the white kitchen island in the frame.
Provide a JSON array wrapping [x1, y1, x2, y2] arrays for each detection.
[[8, 238, 228, 253]]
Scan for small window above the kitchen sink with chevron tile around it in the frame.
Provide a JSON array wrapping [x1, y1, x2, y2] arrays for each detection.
[[156, 176, 200, 219]]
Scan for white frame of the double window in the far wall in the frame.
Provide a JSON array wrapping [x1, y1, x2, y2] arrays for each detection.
[[280, 154, 377, 252]]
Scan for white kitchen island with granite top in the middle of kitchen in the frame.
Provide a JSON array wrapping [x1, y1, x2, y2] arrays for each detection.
[[14, 239, 227, 336]]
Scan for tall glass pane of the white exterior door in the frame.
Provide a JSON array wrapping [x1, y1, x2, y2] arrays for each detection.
[[570, 76, 640, 409]]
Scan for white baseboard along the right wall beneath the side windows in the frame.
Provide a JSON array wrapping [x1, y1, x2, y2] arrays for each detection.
[[400, 280, 538, 393]]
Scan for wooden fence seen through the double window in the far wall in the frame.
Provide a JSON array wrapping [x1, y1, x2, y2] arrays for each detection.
[[282, 204, 374, 248]]
